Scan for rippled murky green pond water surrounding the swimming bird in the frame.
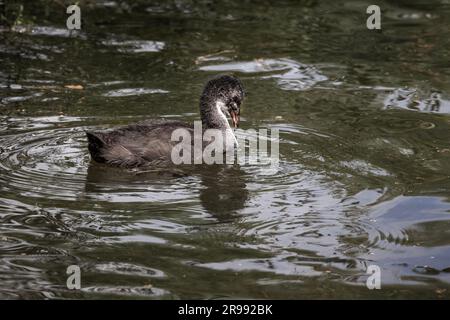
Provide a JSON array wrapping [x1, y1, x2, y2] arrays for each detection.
[[0, 0, 450, 299]]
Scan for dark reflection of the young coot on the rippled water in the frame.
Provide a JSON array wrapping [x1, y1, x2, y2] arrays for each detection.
[[85, 162, 249, 221]]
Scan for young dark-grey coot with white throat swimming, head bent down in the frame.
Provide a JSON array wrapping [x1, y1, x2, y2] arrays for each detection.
[[86, 75, 244, 167]]
